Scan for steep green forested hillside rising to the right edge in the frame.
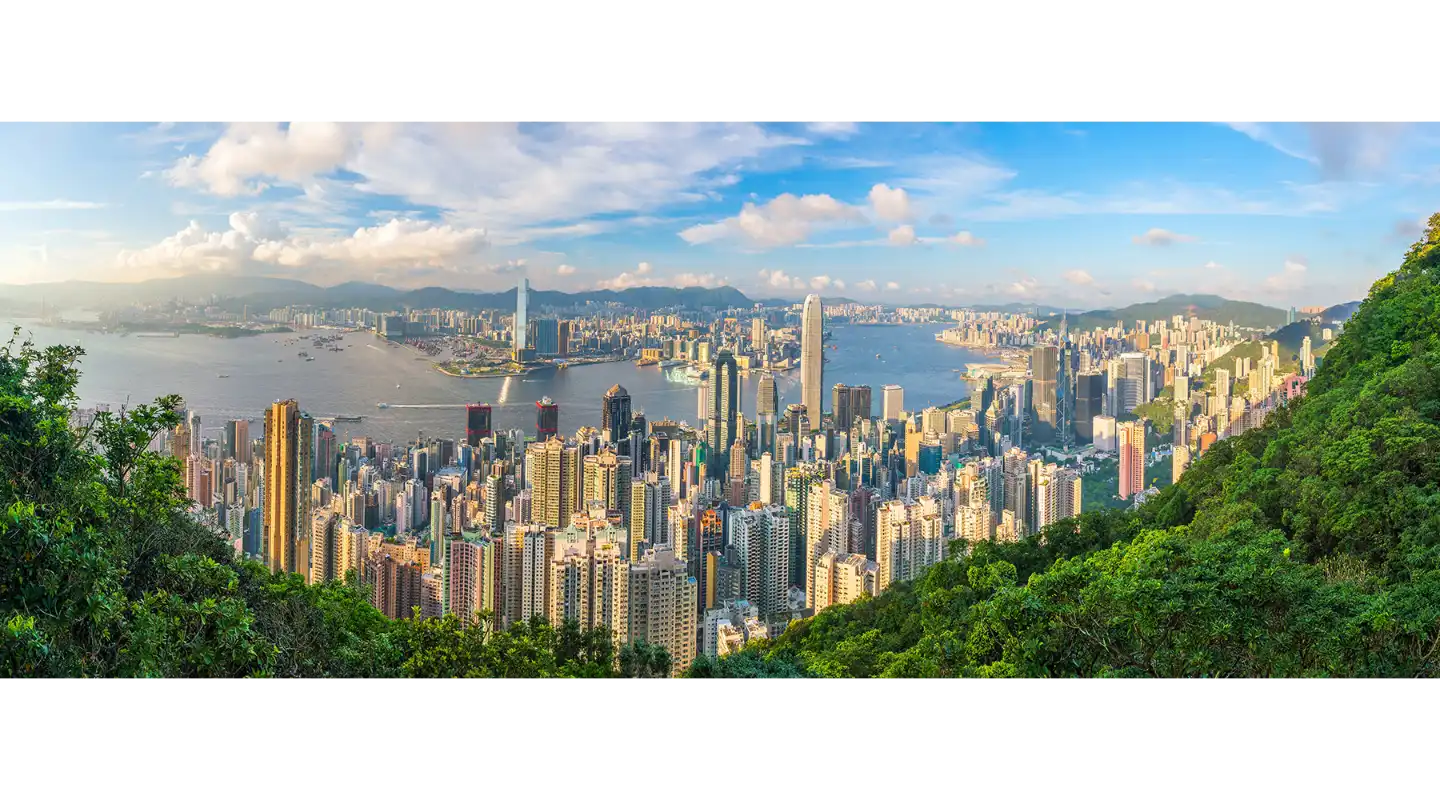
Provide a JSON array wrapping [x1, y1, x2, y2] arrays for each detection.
[[690, 214, 1440, 678]]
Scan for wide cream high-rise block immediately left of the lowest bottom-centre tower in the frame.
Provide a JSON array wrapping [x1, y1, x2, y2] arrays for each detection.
[[546, 535, 629, 646]]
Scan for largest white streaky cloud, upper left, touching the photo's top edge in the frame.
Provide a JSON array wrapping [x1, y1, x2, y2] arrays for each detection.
[[167, 122, 805, 237]]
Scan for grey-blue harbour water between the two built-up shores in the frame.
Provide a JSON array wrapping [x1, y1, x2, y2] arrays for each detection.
[[0, 321, 995, 442]]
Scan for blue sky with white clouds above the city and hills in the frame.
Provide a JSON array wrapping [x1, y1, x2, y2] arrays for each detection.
[[0, 121, 1440, 309]]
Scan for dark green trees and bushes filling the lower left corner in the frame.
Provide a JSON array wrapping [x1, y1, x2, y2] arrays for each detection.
[[0, 333, 670, 678]]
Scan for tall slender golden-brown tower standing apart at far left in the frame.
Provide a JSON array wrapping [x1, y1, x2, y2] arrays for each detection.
[[264, 400, 315, 574]]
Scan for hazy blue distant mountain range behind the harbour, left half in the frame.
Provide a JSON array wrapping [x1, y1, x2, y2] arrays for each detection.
[[3, 275, 755, 312]]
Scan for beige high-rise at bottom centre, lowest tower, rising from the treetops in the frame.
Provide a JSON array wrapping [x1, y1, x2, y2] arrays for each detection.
[[626, 547, 698, 678]]
